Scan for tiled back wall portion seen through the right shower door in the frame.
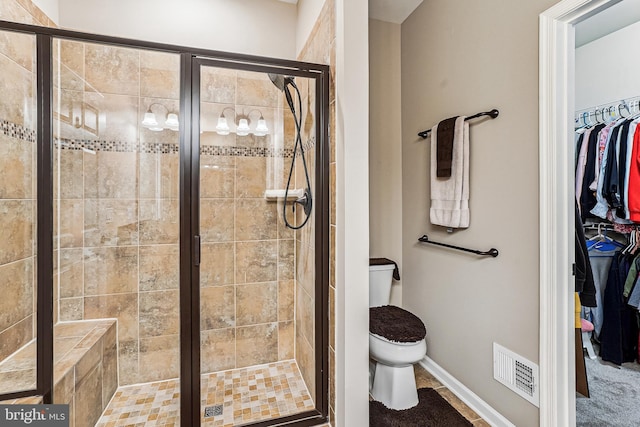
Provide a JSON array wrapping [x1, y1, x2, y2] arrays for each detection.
[[200, 67, 295, 372]]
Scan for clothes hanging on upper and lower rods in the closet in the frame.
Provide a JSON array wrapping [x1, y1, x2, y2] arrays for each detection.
[[575, 104, 640, 364]]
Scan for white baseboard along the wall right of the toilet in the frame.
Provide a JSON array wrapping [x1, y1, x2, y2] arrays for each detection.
[[418, 356, 515, 427]]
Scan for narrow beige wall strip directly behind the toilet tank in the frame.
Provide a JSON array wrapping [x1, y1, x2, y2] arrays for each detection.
[[369, 19, 403, 306]]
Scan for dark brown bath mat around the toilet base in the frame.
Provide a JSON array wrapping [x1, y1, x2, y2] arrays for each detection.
[[369, 388, 473, 427]]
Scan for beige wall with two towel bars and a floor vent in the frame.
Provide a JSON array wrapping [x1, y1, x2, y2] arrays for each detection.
[[402, 0, 555, 426]]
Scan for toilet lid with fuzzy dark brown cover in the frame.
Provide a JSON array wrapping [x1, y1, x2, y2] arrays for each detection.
[[369, 305, 427, 342]]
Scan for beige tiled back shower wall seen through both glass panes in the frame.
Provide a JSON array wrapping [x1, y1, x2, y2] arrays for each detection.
[[54, 45, 302, 385]]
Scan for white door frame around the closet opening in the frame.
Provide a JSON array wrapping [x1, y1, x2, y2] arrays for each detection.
[[539, 0, 621, 427]]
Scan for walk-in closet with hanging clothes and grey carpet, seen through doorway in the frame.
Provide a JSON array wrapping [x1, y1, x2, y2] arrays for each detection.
[[570, 0, 640, 426]]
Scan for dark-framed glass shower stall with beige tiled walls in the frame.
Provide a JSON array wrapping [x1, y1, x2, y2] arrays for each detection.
[[0, 21, 329, 427]]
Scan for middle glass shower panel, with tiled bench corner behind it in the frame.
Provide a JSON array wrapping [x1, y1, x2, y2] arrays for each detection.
[[52, 39, 181, 426]]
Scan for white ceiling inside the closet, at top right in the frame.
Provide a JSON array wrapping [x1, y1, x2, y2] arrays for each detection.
[[576, 0, 640, 47]]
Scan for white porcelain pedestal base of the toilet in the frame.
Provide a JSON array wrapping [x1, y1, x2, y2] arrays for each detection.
[[371, 362, 418, 410]]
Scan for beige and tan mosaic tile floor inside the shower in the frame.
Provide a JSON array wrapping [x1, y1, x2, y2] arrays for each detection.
[[96, 361, 314, 427]]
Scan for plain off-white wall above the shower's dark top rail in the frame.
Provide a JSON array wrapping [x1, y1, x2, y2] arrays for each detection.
[[59, 0, 296, 59]]
